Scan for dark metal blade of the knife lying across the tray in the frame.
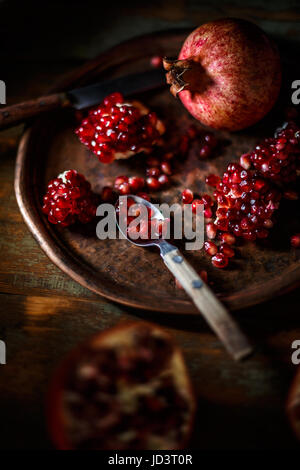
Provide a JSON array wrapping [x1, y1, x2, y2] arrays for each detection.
[[67, 70, 166, 109]]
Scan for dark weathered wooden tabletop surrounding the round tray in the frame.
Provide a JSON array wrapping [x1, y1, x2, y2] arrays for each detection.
[[0, 0, 300, 449]]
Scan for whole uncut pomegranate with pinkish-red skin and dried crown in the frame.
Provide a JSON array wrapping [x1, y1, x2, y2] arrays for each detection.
[[164, 18, 281, 131]]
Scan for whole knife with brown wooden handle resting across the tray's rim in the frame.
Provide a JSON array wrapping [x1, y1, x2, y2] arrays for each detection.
[[0, 69, 165, 129]]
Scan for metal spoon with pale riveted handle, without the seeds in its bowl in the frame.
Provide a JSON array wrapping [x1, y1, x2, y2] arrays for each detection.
[[116, 195, 252, 360]]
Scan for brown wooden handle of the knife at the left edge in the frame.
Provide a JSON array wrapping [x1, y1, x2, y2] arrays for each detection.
[[0, 93, 71, 129]]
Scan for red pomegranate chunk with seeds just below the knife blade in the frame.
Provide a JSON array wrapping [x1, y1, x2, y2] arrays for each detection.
[[75, 92, 165, 163]]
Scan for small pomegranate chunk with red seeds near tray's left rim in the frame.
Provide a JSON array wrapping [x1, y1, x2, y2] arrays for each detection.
[[42, 170, 98, 227]]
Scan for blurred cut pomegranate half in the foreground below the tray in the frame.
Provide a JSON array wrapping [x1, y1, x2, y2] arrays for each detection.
[[48, 322, 196, 450]]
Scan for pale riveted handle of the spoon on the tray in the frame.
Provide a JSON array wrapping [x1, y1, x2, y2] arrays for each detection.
[[161, 248, 252, 360]]
